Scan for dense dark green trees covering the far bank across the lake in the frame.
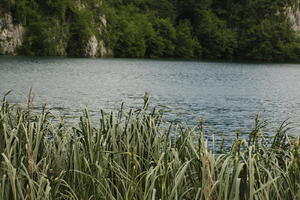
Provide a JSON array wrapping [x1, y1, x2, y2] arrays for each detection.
[[1, 0, 300, 61]]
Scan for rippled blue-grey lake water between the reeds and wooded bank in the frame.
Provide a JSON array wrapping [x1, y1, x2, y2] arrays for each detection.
[[0, 57, 300, 140]]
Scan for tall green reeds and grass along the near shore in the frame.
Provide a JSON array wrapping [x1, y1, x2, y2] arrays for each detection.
[[0, 94, 300, 200]]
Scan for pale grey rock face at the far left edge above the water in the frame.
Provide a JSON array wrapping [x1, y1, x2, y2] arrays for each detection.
[[0, 11, 25, 55]]
